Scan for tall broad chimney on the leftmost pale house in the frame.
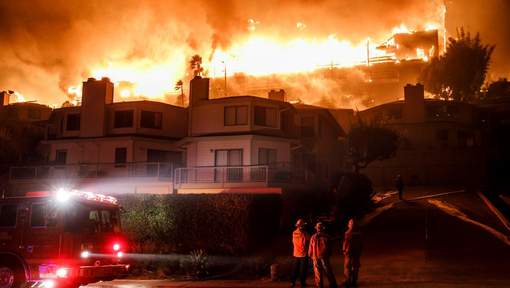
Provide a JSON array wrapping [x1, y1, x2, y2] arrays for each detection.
[[80, 77, 113, 137]]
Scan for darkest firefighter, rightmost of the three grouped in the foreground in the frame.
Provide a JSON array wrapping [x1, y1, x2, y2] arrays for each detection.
[[342, 219, 363, 287]]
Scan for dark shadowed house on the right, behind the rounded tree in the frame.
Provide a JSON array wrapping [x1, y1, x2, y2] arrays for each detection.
[[357, 84, 483, 187]]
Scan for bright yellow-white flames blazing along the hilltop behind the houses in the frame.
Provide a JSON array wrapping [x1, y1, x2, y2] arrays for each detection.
[[67, 23, 439, 101]]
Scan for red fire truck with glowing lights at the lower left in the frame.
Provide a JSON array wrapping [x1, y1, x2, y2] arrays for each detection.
[[0, 189, 129, 288]]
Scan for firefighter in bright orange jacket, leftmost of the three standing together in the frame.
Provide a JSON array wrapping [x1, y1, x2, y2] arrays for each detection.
[[291, 219, 310, 287]]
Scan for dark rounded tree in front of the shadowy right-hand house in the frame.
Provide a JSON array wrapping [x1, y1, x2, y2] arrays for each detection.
[[347, 119, 400, 173]]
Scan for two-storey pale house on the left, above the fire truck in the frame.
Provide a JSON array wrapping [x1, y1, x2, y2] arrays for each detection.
[[10, 78, 187, 193]]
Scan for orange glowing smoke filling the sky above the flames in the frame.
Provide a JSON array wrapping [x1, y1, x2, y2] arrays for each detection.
[[0, 0, 502, 105]]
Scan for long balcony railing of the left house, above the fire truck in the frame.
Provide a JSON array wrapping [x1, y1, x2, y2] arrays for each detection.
[[9, 162, 174, 180]]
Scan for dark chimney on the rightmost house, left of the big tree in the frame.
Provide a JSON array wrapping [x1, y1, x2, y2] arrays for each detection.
[[403, 84, 425, 122]]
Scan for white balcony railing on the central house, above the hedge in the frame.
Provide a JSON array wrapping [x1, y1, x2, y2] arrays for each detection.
[[174, 165, 269, 189]]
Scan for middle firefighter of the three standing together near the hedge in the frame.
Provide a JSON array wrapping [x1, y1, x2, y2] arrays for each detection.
[[308, 222, 337, 288]]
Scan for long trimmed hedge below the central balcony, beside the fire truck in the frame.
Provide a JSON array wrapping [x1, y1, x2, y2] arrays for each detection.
[[118, 194, 282, 254]]
